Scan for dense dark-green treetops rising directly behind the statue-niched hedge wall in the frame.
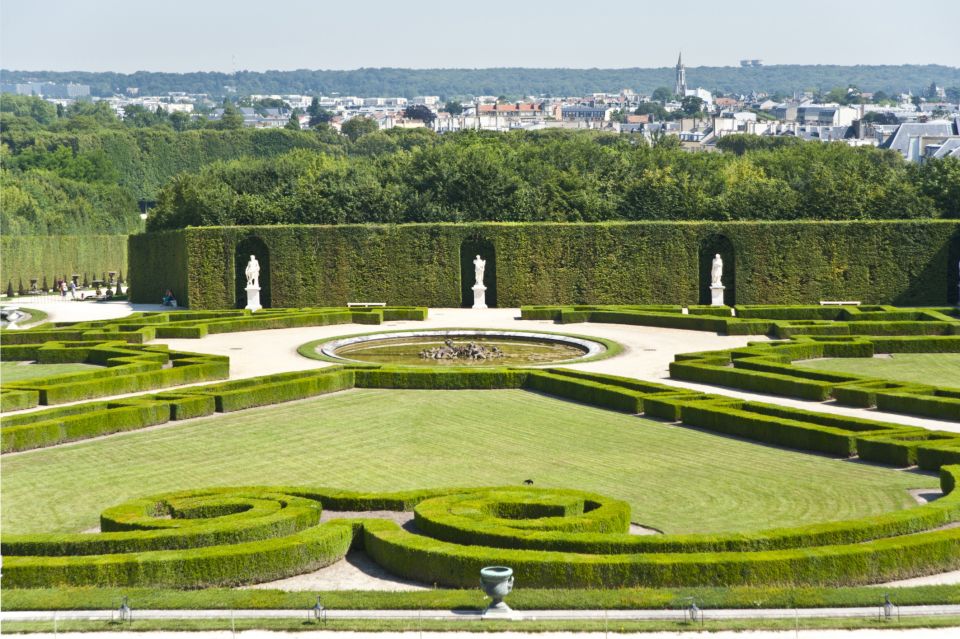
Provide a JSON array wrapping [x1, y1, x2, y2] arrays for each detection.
[[149, 131, 952, 230]]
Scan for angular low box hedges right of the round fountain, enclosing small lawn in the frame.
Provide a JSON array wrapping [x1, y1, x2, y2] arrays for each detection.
[[521, 306, 960, 421]]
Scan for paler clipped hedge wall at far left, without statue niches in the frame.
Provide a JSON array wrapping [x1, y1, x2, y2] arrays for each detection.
[[0, 235, 128, 289]]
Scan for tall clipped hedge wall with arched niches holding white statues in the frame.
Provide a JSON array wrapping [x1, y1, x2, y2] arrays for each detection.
[[130, 220, 960, 308]]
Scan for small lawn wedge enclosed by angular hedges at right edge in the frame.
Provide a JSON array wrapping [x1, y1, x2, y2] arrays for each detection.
[[794, 353, 960, 388]]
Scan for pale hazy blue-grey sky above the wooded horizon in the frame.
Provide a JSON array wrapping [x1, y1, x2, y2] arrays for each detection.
[[0, 0, 960, 73]]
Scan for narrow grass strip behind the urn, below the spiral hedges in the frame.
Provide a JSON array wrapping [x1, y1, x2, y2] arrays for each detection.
[[7, 585, 960, 611]]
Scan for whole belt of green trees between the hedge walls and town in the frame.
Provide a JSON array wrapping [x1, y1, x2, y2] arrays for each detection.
[[0, 96, 960, 235]]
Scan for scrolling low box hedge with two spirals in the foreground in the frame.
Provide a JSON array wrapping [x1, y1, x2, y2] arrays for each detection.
[[2, 466, 960, 588]]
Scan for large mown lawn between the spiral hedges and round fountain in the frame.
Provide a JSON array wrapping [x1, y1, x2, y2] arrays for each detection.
[[2, 389, 938, 533]]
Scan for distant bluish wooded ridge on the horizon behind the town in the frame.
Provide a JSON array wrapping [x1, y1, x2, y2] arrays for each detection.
[[2, 64, 960, 99]]
